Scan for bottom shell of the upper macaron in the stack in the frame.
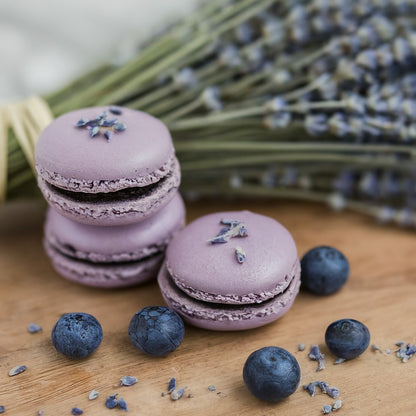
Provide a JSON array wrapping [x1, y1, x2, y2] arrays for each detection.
[[38, 158, 181, 226]]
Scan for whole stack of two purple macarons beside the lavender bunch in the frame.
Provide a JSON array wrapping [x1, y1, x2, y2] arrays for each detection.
[[35, 106, 185, 287]]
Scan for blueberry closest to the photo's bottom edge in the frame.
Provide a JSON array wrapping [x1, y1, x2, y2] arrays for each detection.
[[243, 347, 300, 402]]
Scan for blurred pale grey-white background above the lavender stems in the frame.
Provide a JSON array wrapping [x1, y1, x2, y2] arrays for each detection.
[[0, 0, 201, 104]]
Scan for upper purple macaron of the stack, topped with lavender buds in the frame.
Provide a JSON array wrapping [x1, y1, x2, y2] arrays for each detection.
[[35, 106, 180, 226]]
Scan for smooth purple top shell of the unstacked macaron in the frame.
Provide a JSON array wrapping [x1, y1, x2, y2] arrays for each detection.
[[166, 211, 298, 304]]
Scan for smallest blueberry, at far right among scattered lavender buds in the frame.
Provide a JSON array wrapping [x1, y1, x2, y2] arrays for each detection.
[[325, 319, 370, 360]]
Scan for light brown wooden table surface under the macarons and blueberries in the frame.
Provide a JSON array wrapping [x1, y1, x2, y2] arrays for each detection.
[[0, 201, 416, 416]]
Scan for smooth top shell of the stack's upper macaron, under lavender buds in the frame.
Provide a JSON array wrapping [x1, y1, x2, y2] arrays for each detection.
[[35, 106, 174, 188]]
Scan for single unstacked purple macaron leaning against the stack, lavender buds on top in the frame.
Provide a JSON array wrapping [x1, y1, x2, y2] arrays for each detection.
[[158, 211, 300, 331]]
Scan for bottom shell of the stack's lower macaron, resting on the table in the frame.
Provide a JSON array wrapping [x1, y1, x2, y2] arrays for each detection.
[[44, 240, 164, 288]]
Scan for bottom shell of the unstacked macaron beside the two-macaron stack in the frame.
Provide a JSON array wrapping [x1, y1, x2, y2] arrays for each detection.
[[158, 262, 300, 331]]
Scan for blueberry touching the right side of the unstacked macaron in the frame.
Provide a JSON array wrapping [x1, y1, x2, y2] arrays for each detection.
[[301, 246, 350, 295]]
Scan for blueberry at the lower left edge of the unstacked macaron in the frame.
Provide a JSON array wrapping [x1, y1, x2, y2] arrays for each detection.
[[129, 306, 185, 356]]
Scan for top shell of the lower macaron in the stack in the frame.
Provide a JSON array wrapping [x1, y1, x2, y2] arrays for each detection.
[[45, 193, 185, 262]]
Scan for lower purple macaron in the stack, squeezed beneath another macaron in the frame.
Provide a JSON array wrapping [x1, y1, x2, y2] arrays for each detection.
[[44, 193, 185, 288]]
